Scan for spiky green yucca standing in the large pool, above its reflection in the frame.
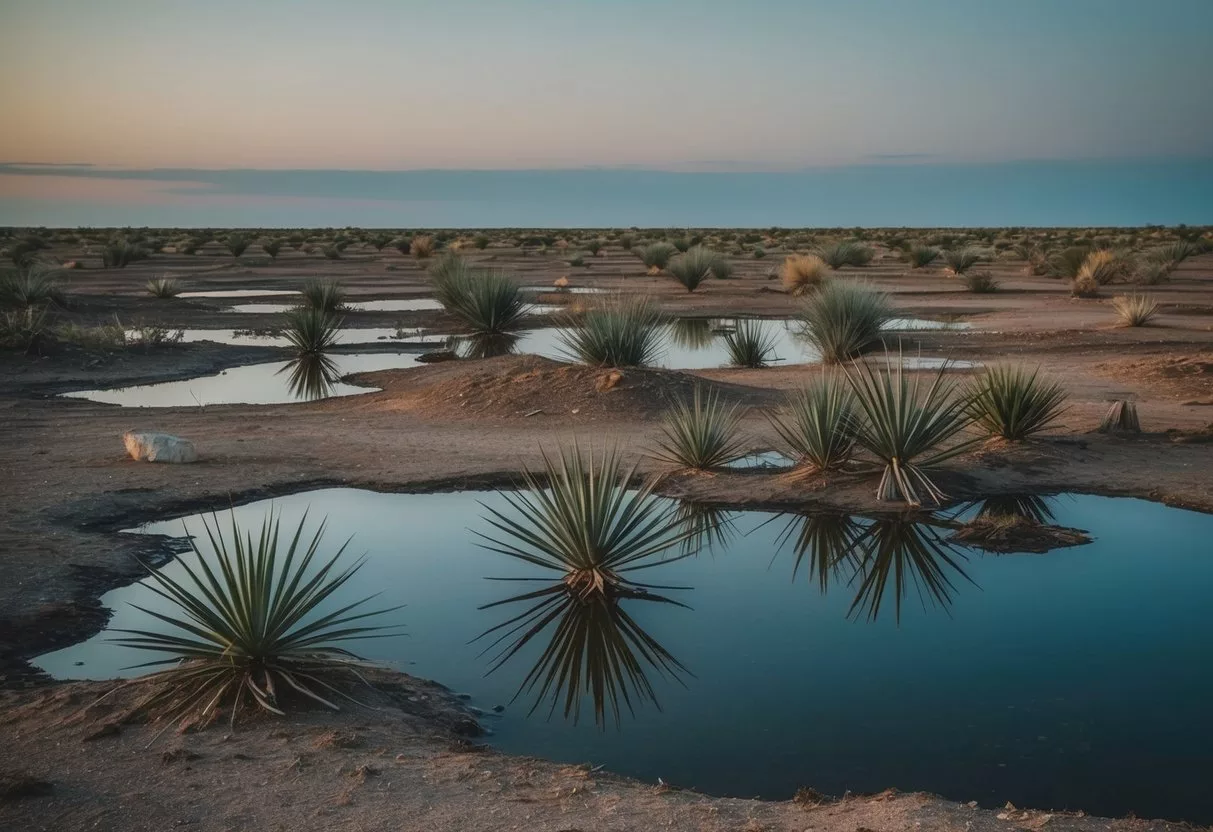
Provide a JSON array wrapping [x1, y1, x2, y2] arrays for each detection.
[[477, 444, 688, 598]]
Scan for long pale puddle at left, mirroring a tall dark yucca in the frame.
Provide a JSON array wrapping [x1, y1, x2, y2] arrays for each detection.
[[63, 353, 420, 408]]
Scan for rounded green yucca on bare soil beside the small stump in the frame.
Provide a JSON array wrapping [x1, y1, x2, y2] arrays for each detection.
[[964, 366, 1066, 440]]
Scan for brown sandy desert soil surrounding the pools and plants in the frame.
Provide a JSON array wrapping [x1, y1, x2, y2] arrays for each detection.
[[0, 237, 1213, 830]]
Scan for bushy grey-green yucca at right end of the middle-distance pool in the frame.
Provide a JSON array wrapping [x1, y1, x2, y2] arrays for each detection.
[[801, 280, 893, 364]]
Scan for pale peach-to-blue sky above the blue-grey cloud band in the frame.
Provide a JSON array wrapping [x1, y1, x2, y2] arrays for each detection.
[[0, 0, 1213, 170]]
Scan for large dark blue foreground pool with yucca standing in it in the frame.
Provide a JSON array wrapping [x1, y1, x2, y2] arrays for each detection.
[[38, 489, 1213, 824]]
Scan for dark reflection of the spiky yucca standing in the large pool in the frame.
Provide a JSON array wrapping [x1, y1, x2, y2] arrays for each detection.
[[477, 581, 690, 728]]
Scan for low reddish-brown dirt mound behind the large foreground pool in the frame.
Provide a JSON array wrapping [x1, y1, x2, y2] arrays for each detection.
[[354, 355, 764, 420]]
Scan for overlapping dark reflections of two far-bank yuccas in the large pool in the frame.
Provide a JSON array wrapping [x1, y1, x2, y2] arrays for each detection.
[[779, 512, 976, 622]]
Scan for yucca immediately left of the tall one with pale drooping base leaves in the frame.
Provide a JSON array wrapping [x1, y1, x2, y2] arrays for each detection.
[[770, 374, 856, 471]]
